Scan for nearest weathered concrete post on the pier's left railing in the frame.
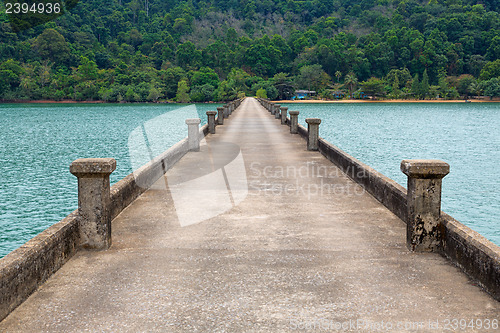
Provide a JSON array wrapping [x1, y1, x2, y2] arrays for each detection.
[[69, 158, 116, 250]]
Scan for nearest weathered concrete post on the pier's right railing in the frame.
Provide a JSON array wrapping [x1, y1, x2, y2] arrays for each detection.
[[401, 160, 450, 252]]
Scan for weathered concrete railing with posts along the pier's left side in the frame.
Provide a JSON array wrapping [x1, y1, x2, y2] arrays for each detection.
[[0, 100, 241, 321]]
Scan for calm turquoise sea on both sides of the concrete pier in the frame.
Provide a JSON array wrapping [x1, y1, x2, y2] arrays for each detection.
[[0, 103, 500, 258]]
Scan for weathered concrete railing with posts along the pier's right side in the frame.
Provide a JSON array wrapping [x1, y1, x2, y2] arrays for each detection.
[[259, 99, 500, 301]]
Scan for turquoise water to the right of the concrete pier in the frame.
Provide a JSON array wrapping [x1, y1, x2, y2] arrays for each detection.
[[286, 103, 500, 245]]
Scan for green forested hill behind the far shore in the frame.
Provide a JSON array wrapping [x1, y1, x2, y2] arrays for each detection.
[[0, 0, 500, 102]]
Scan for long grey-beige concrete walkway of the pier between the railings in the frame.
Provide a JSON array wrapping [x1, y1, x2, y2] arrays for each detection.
[[0, 98, 500, 332]]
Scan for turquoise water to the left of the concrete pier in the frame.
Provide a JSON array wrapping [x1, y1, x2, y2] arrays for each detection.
[[0, 104, 219, 258]]
